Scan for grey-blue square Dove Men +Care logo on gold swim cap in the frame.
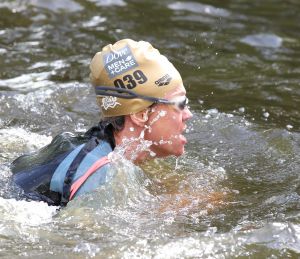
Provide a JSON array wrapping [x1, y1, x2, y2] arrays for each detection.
[[103, 45, 138, 78]]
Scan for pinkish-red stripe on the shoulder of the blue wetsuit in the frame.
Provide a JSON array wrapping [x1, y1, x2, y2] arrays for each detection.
[[69, 156, 110, 201]]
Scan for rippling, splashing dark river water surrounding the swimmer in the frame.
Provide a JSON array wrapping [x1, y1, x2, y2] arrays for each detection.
[[0, 0, 300, 258]]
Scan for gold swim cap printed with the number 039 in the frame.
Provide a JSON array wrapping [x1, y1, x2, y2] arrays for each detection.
[[90, 39, 182, 117]]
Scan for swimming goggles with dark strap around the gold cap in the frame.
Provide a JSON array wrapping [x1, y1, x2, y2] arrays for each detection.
[[95, 86, 189, 110]]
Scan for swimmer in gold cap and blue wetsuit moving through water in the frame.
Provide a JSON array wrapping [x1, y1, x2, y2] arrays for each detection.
[[12, 39, 192, 206]]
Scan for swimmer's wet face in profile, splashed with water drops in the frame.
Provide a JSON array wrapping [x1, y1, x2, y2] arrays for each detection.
[[145, 85, 192, 157]]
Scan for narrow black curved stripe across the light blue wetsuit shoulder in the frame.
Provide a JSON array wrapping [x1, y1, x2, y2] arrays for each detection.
[[61, 137, 99, 206]]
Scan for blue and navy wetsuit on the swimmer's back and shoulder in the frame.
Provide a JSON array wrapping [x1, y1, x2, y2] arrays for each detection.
[[13, 134, 112, 206]]
